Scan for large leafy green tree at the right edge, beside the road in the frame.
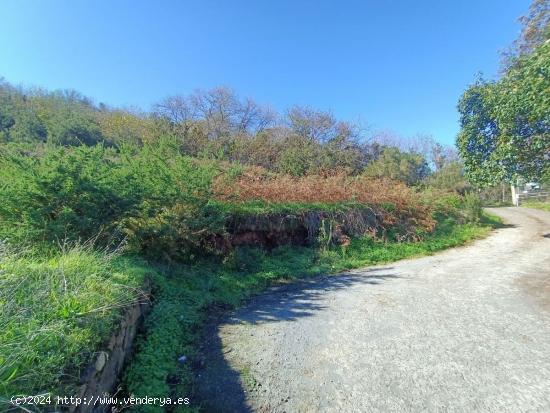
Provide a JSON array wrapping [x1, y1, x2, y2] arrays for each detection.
[[457, 41, 550, 186]]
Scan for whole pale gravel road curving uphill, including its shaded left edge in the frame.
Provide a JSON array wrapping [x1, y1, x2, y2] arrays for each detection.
[[199, 208, 550, 413]]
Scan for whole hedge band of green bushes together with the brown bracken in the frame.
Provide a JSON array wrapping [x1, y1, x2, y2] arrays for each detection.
[[0, 139, 444, 260]]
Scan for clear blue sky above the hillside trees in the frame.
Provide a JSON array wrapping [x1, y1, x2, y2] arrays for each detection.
[[0, 0, 529, 143]]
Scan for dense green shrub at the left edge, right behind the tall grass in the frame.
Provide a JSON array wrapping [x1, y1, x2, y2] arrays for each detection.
[[0, 146, 135, 242]]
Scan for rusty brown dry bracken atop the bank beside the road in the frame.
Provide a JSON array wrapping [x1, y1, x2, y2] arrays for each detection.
[[214, 168, 435, 243]]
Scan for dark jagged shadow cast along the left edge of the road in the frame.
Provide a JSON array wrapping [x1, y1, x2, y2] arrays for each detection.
[[194, 267, 399, 413]]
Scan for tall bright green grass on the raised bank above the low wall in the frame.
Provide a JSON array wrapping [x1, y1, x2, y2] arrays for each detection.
[[0, 244, 147, 400]]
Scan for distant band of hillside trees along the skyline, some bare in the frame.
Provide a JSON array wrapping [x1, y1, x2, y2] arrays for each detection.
[[0, 78, 466, 184]]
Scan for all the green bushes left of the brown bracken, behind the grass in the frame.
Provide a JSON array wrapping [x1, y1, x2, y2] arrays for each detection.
[[0, 142, 224, 257]]
